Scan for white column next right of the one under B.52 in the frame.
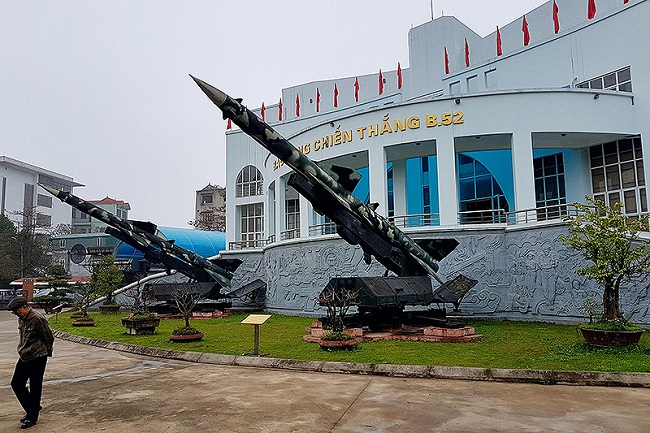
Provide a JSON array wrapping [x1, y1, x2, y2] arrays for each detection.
[[510, 131, 537, 211]]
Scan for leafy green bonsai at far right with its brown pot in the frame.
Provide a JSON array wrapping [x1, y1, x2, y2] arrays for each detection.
[[558, 197, 650, 347]]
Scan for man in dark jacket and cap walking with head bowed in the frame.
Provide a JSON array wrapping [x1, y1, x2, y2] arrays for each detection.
[[7, 296, 54, 429]]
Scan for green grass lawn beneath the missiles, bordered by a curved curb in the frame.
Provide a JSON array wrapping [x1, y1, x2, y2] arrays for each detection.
[[50, 313, 650, 372]]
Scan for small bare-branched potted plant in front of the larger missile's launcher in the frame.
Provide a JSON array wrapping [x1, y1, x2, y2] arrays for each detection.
[[318, 286, 359, 349]]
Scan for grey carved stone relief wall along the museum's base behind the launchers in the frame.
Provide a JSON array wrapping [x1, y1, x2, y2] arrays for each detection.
[[227, 224, 650, 324]]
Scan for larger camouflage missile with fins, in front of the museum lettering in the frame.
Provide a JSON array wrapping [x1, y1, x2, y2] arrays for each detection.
[[190, 75, 458, 284]]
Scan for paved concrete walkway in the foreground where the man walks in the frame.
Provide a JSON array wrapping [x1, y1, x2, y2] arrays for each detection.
[[0, 311, 650, 433]]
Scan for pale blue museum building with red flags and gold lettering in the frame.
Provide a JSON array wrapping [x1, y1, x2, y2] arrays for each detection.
[[215, 0, 650, 323]]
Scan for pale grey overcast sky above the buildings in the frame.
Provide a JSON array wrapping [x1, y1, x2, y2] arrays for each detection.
[[0, 0, 545, 227]]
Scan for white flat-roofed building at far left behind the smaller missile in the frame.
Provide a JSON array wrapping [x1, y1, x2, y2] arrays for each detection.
[[0, 156, 83, 227]]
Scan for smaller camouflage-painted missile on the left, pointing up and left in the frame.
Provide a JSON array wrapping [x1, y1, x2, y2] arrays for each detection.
[[39, 184, 239, 287]]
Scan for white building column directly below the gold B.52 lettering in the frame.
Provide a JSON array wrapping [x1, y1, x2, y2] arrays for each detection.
[[436, 133, 458, 226]]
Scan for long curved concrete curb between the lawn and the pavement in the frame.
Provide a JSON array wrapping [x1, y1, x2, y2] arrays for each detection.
[[52, 330, 650, 388]]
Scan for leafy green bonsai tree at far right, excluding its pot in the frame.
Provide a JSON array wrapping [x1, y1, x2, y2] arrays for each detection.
[[558, 197, 650, 322]]
